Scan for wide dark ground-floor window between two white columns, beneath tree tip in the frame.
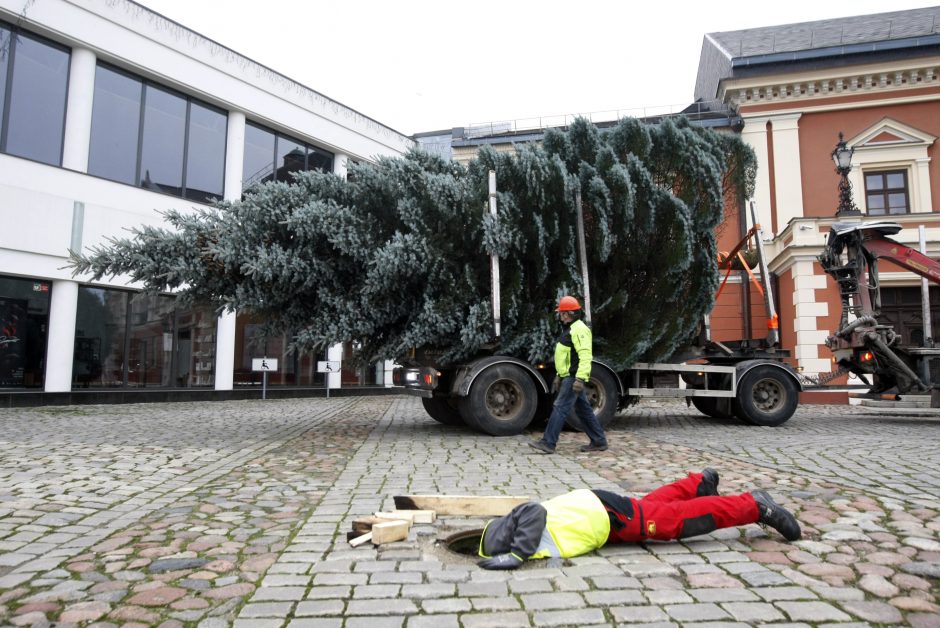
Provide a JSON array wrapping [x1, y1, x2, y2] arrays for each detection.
[[72, 286, 216, 388]]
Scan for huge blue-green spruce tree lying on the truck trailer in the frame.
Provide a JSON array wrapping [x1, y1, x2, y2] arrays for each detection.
[[72, 118, 756, 367]]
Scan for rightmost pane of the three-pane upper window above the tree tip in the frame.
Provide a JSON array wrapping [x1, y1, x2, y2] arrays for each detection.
[[186, 103, 228, 202]]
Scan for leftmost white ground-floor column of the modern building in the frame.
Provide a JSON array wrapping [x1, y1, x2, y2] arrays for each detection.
[[43, 279, 78, 392]]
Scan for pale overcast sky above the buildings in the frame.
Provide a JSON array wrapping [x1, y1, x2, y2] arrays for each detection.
[[137, 0, 936, 135]]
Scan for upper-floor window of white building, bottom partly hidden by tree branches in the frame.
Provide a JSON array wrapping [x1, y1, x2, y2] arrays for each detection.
[[242, 123, 333, 190]]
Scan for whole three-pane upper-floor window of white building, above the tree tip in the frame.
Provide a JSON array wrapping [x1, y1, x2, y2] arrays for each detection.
[[88, 64, 228, 202]]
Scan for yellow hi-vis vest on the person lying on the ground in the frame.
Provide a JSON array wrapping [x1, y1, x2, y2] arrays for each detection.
[[529, 489, 610, 558]]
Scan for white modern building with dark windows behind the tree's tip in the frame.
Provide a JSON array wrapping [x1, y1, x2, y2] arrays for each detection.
[[0, 0, 413, 400]]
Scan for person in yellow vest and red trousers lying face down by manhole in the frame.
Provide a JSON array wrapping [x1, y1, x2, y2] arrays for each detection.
[[478, 469, 802, 569]]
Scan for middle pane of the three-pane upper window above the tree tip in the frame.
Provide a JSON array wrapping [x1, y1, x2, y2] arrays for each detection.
[[138, 85, 186, 196]]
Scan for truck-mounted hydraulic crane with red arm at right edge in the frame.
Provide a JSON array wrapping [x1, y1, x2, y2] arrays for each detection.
[[818, 221, 940, 394]]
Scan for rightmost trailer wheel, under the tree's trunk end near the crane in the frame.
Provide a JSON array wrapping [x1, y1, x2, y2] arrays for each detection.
[[731, 365, 799, 427]]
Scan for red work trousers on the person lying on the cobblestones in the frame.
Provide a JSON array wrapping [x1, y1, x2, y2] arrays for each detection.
[[607, 473, 760, 543]]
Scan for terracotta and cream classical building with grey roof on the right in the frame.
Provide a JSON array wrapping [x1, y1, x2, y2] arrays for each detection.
[[695, 7, 940, 392]]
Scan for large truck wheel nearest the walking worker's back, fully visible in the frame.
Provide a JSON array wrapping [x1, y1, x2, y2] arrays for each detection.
[[459, 364, 538, 436]]
